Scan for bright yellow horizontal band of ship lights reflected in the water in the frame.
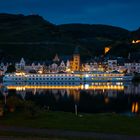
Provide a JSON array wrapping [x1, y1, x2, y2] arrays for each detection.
[[7, 82, 124, 92]]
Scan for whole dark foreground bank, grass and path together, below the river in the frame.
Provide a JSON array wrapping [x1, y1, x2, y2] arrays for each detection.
[[0, 111, 140, 140]]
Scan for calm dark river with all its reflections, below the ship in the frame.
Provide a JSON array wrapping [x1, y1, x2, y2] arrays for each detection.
[[0, 82, 140, 113]]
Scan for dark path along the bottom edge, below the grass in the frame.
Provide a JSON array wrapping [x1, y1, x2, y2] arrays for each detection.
[[0, 126, 140, 140]]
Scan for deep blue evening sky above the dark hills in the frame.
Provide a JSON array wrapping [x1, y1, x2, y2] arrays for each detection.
[[0, 0, 140, 30]]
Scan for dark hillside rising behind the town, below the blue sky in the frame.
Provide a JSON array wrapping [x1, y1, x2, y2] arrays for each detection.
[[0, 14, 140, 60]]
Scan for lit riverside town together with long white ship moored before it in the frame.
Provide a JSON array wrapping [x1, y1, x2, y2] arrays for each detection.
[[1, 44, 140, 83]]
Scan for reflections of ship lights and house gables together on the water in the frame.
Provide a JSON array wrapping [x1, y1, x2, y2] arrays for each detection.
[[7, 82, 140, 101]]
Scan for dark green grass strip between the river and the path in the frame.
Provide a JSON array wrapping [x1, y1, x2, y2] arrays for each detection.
[[0, 112, 140, 135]]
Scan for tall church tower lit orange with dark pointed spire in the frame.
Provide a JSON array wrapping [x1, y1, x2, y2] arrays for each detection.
[[72, 47, 80, 71]]
